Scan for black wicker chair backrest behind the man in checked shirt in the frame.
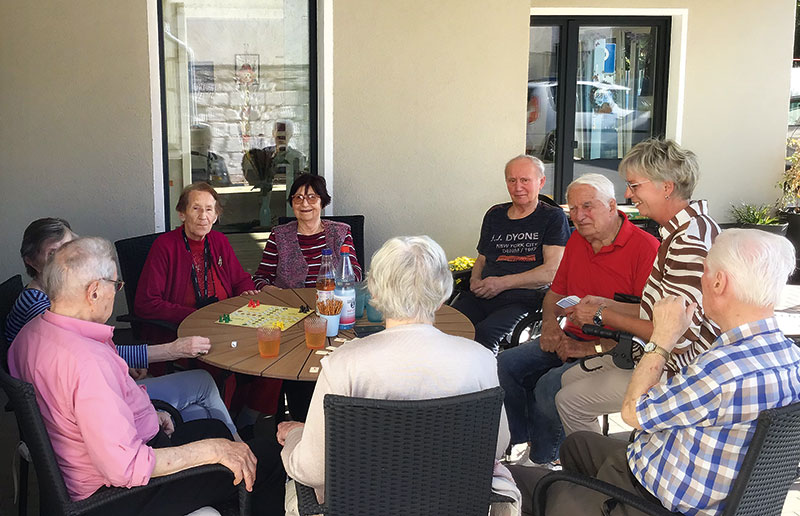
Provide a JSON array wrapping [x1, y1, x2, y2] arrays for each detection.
[[723, 403, 800, 516]]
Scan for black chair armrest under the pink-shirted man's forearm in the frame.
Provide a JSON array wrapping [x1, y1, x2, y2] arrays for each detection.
[[70, 464, 250, 516]]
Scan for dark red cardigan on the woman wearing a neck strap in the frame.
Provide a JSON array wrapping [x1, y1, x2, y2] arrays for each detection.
[[134, 227, 255, 324]]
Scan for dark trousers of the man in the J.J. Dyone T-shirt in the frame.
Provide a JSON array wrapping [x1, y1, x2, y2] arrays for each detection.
[[453, 289, 544, 353]]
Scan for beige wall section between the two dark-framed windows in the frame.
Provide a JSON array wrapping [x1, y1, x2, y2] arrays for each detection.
[[333, 0, 529, 264]]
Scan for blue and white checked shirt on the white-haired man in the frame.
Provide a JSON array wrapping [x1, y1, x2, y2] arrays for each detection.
[[628, 318, 800, 515]]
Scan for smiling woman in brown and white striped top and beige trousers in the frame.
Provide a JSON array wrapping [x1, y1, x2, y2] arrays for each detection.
[[556, 139, 720, 434]]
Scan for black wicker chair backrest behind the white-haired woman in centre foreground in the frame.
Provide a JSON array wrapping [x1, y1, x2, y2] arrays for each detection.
[[323, 387, 503, 516]]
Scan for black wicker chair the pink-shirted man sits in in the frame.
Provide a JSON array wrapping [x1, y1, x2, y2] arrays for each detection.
[[0, 367, 250, 516]]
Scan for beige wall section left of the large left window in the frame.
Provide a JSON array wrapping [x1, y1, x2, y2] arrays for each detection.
[[0, 0, 163, 314]]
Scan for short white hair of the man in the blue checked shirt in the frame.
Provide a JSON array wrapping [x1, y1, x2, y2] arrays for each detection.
[[706, 229, 795, 307]]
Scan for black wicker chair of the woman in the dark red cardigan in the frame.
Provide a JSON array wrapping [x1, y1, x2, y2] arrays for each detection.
[[114, 233, 178, 340]]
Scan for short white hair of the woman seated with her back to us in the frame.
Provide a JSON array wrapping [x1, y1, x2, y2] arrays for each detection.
[[367, 235, 453, 323]]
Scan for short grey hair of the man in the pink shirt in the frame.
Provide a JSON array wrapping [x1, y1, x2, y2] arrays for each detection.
[[42, 237, 117, 301]]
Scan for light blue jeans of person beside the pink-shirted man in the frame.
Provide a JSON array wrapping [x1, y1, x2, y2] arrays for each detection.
[[136, 369, 236, 434]]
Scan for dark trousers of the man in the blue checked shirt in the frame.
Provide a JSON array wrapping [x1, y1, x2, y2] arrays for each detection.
[[508, 432, 660, 516]]
